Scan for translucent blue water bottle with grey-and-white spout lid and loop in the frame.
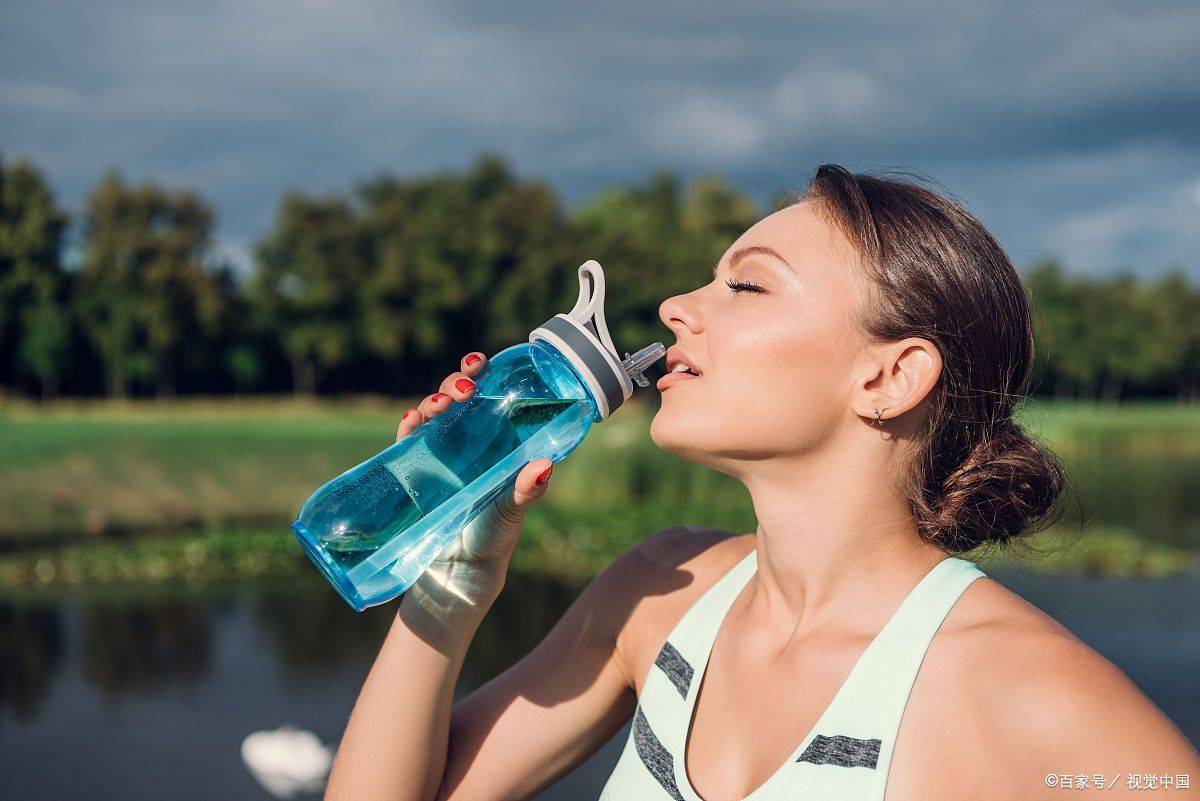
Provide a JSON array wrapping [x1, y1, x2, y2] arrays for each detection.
[[292, 260, 666, 612]]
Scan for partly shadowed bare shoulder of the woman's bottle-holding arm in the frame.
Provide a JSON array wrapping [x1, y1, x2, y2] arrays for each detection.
[[606, 525, 755, 693]]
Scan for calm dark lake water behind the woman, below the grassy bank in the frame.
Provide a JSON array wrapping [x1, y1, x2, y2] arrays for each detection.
[[0, 570, 1200, 801]]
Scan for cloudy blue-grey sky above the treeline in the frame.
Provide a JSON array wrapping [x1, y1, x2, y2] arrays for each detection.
[[0, 0, 1200, 281]]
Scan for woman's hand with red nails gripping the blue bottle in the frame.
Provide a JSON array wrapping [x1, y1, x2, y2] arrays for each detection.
[[396, 351, 554, 636]]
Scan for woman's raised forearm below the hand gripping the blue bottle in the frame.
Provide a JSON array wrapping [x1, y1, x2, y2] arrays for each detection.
[[325, 587, 490, 801]]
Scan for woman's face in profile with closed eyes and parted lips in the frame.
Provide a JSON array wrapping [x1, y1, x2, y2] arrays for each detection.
[[650, 201, 866, 474]]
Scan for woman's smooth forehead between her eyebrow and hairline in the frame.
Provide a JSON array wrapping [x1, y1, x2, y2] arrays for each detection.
[[726, 200, 857, 281]]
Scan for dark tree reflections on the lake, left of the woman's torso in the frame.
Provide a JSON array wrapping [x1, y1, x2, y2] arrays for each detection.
[[0, 576, 592, 719]]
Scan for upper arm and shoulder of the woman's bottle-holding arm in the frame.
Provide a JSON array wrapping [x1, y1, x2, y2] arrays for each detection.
[[438, 525, 745, 801]]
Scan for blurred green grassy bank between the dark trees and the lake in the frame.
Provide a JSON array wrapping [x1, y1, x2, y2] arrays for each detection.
[[0, 398, 1200, 588]]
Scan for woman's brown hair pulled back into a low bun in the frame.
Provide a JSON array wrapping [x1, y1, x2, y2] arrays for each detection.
[[793, 164, 1067, 553]]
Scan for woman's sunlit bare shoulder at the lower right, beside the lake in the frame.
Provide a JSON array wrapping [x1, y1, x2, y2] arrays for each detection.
[[912, 577, 1200, 791]]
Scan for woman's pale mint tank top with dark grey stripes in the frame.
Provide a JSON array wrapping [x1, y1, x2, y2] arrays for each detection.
[[600, 550, 984, 801]]
